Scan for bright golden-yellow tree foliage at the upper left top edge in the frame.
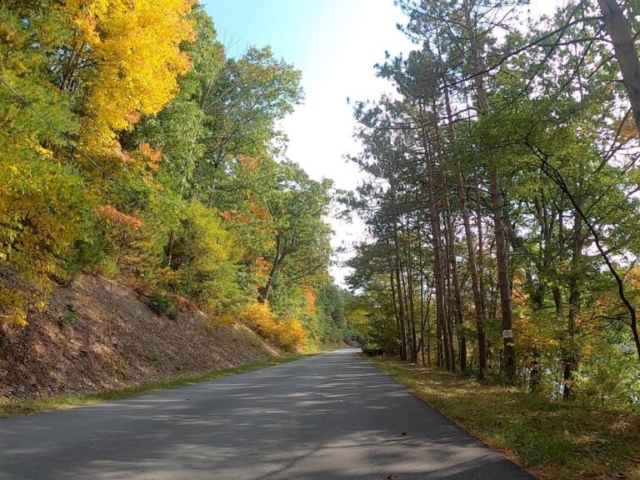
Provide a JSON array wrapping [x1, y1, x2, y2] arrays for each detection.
[[60, 0, 194, 153]]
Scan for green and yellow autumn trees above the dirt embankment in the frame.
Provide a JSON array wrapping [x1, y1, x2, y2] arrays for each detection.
[[0, 0, 352, 351]]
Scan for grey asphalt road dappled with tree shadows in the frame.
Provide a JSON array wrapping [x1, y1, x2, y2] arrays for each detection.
[[0, 350, 532, 480]]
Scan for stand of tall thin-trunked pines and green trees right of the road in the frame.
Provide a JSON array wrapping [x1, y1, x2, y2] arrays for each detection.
[[348, 0, 640, 407]]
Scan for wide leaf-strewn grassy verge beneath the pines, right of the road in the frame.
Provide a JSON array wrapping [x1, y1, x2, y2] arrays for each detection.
[[370, 359, 640, 480]]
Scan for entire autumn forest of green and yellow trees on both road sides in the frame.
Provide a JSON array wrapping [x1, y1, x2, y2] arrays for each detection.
[[0, 0, 640, 405]]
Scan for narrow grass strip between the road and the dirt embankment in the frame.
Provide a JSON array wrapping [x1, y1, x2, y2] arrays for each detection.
[[0, 355, 307, 417]]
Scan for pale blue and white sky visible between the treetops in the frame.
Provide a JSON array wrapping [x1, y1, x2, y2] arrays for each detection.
[[203, 0, 563, 284]]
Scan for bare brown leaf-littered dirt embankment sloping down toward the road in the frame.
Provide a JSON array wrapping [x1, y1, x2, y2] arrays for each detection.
[[0, 276, 280, 398]]
